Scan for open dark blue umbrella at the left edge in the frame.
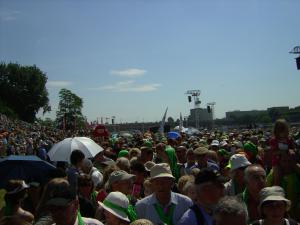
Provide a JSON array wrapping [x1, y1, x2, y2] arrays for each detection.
[[0, 155, 55, 188]]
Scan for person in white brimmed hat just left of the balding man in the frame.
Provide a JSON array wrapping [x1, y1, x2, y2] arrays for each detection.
[[224, 154, 251, 196]]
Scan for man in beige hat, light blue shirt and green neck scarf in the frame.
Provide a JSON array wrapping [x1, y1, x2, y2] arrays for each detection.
[[135, 163, 193, 225]]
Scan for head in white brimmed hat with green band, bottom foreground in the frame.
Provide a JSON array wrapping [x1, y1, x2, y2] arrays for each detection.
[[99, 191, 136, 225]]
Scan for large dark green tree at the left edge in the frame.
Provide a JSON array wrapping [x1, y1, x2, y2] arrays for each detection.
[[0, 63, 51, 122]]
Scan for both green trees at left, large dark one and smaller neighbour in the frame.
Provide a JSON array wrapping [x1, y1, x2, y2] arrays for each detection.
[[0, 62, 85, 129]]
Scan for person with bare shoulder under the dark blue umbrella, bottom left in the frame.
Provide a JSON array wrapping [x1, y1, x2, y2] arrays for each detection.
[[0, 180, 34, 223]]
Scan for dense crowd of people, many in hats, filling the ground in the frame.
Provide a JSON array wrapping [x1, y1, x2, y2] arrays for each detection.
[[0, 115, 300, 225]]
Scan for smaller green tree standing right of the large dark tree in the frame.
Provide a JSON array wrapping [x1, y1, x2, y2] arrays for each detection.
[[56, 88, 84, 129]]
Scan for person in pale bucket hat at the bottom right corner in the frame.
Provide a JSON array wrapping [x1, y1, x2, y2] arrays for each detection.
[[252, 186, 298, 225]]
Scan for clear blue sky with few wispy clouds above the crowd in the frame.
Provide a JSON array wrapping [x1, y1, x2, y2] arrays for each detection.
[[0, 0, 300, 122]]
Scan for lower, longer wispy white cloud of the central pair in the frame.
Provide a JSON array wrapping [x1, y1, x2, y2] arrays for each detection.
[[91, 80, 161, 92]]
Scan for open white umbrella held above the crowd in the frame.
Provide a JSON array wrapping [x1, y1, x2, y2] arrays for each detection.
[[48, 137, 103, 162]]
